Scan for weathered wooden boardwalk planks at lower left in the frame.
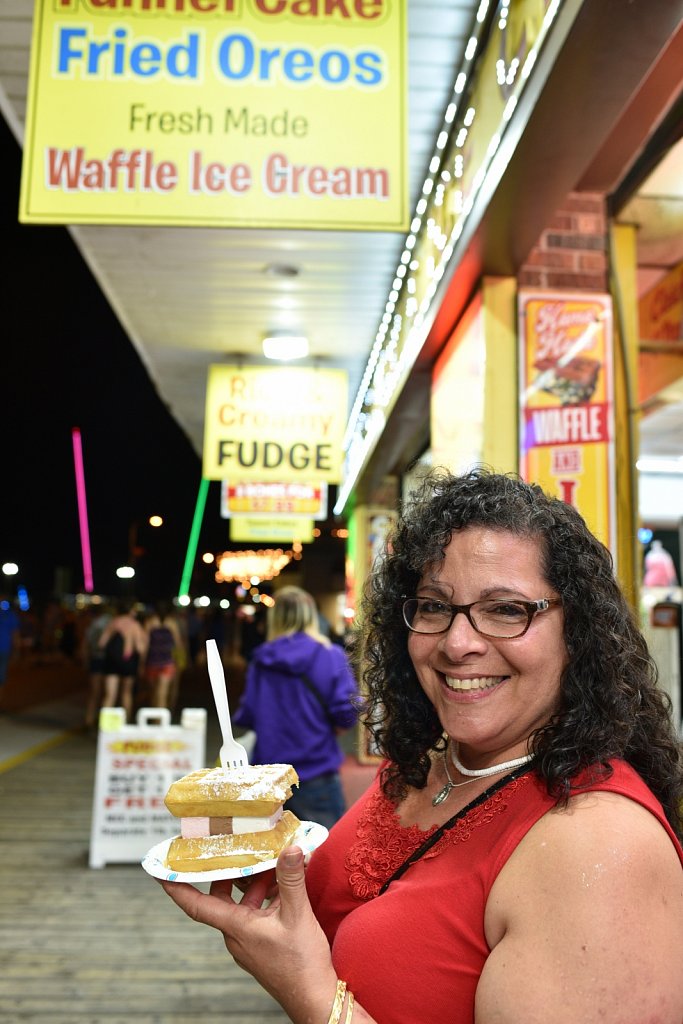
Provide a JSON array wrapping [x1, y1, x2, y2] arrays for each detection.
[[0, 735, 288, 1024]]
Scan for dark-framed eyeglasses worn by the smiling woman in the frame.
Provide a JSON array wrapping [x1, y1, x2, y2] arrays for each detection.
[[403, 597, 562, 640]]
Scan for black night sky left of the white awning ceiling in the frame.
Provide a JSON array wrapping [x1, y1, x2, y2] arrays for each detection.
[[0, 118, 227, 600]]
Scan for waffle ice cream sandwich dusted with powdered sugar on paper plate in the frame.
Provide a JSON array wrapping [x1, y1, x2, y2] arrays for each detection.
[[165, 765, 300, 871]]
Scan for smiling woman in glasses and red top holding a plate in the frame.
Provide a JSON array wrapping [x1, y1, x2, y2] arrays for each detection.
[[157, 472, 683, 1024]]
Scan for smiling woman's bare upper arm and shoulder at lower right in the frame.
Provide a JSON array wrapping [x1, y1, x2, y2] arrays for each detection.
[[475, 793, 683, 1024]]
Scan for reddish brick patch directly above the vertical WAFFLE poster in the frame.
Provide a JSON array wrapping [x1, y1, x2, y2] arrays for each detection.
[[517, 193, 607, 292]]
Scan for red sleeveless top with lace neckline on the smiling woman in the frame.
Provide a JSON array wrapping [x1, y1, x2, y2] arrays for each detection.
[[306, 762, 683, 1024]]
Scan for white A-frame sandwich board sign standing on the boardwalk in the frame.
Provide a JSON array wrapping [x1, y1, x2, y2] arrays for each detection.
[[89, 708, 207, 867]]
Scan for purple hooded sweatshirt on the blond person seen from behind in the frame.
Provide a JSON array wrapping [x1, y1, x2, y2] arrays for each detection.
[[232, 633, 357, 781]]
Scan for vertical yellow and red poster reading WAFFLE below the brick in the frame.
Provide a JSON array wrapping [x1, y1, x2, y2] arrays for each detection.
[[519, 292, 616, 553]]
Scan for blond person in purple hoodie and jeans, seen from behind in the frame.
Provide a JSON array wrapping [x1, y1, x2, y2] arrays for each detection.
[[232, 587, 357, 828]]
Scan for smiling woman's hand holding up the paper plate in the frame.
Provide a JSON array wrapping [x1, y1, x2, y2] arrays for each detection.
[[161, 847, 337, 1024]]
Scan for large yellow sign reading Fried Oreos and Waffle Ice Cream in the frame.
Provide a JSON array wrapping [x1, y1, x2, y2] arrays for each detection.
[[19, 0, 410, 230]]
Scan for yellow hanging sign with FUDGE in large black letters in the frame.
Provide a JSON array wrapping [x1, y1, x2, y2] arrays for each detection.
[[203, 366, 348, 483]]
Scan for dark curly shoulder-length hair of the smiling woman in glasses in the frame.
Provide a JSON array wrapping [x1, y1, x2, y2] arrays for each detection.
[[353, 469, 683, 836]]
